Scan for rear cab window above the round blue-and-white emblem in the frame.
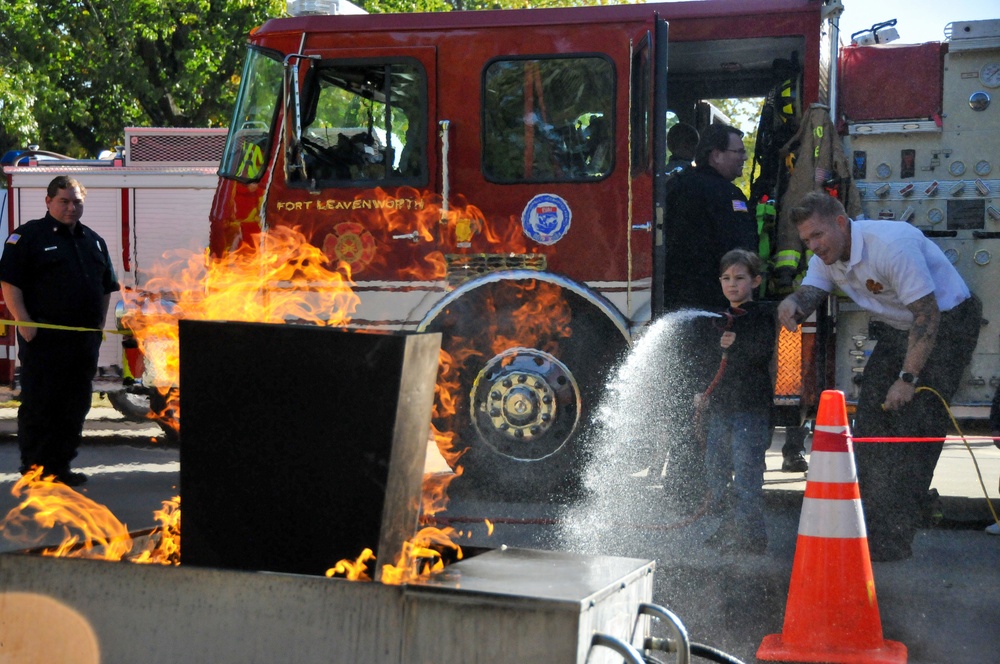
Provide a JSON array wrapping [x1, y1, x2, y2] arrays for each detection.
[[482, 56, 615, 183]]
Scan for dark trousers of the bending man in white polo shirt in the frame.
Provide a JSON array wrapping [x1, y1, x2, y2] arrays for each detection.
[[853, 296, 982, 558]]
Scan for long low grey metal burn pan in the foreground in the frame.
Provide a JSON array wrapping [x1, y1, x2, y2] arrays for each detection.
[[0, 549, 655, 664]]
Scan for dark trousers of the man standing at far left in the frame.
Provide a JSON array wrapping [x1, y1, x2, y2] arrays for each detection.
[[17, 329, 101, 474]]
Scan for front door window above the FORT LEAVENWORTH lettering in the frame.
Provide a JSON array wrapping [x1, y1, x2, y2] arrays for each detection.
[[292, 62, 427, 186]]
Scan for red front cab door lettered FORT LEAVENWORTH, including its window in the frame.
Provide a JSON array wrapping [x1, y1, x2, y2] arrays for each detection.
[[279, 44, 441, 281]]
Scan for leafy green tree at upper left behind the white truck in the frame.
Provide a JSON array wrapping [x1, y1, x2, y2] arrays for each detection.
[[0, 0, 285, 157]]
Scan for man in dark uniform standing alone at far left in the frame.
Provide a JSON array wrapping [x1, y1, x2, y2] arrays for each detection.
[[0, 176, 120, 486]]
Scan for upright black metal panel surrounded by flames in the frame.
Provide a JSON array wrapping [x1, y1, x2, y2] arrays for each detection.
[[180, 321, 440, 574]]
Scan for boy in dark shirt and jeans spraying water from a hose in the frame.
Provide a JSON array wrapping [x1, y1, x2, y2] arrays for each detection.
[[697, 249, 778, 555]]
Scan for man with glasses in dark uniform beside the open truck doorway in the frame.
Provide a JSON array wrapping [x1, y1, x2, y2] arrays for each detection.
[[664, 124, 758, 311]]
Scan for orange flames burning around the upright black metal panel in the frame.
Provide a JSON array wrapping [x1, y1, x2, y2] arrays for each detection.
[[23, 189, 571, 583]]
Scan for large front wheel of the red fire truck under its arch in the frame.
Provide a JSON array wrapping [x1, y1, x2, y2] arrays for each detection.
[[422, 272, 629, 498]]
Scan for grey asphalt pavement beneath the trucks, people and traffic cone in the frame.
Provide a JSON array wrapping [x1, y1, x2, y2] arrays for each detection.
[[0, 407, 1000, 664]]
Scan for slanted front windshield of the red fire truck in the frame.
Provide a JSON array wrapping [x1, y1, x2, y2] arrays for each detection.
[[219, 49, 282, 182]]
